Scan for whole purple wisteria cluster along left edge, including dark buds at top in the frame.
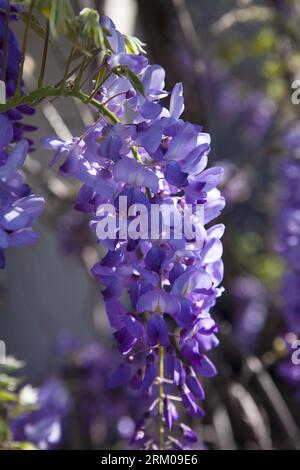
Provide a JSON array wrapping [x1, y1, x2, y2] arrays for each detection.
[[0, 1, 44, 268]]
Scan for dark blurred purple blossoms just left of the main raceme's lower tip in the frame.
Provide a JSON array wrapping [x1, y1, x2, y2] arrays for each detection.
[[60, 334, 143, 449]]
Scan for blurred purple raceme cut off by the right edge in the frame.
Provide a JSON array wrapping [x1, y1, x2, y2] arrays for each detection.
[[277, 123, 300, 387]]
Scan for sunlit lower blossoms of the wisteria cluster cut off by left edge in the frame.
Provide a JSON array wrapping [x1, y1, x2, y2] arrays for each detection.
[[0, 114, 44, 268]]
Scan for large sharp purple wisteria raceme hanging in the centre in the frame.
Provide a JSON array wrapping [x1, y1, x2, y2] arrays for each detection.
[[44, 13, 224, 448]]
